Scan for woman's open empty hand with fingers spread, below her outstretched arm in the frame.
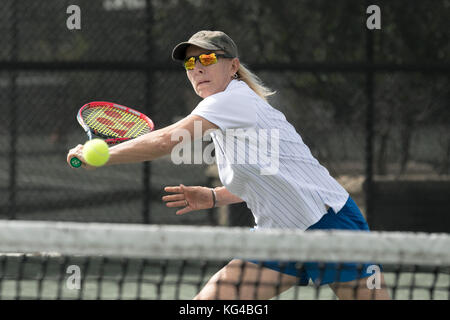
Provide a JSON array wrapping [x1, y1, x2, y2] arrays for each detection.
[[162, 184, 214, 215]]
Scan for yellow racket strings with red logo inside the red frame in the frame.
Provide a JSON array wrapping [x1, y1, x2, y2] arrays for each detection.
[[82, 106, 151, 138]]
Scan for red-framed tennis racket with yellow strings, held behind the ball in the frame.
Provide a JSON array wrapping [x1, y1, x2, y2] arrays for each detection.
[[70, 101, 155, 168]]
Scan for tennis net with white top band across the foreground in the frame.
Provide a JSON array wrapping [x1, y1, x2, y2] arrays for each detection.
[[0, 221, 450, 300]]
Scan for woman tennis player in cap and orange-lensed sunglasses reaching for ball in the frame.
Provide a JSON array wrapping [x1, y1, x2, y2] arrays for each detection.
[[67, 31, 389, 299]]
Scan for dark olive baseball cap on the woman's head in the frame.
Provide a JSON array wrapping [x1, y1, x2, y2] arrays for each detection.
[[172, 30, 238, 60]]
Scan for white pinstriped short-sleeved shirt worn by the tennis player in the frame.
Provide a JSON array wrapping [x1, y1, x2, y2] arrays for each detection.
[[191, 80, 349, 230]]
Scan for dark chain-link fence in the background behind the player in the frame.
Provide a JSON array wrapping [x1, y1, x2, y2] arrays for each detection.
[[0, 0, 450, 231]]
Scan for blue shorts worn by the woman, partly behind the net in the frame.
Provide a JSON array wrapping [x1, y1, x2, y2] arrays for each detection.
[[250, 197, 378, 286]]
